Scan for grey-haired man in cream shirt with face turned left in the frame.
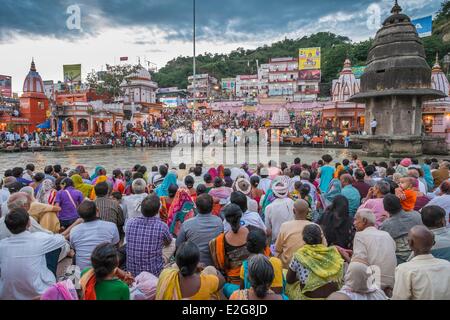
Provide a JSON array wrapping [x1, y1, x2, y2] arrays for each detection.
[[352, 209, 397, 295]]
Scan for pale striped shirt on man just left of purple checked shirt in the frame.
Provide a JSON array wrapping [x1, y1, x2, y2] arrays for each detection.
[[70, 220, 120, 271]]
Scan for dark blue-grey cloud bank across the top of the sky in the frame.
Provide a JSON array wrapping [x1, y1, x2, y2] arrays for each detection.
[[0, 0, 442, 44]]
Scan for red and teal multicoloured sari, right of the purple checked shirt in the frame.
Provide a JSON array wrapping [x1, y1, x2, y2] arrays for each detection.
[[167, 188, 195, 237]]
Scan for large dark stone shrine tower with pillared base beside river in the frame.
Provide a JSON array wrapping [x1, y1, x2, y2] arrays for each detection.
[[350, 1, 446, 157]]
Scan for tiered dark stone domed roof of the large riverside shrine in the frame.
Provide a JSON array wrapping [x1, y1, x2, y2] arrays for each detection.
[[351, 1, 442, 102]]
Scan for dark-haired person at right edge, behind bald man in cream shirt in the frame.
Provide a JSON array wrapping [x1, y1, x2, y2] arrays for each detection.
[[421, 206, 450, 262]]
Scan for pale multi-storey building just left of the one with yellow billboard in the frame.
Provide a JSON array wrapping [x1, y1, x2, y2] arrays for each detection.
[[269, 57, 298, 101]]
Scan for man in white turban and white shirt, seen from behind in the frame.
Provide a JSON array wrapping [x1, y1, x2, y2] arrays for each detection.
[[265, 181, 294, 243]]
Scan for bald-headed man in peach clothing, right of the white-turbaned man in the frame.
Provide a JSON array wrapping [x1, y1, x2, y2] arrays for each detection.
[[275, 199, 327, 269]]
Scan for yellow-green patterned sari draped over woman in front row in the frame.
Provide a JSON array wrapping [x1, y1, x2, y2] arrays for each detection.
[[286, 244, 344, 300]]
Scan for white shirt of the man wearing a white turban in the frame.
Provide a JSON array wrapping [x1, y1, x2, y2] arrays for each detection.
[[265, 198, 294, 242]]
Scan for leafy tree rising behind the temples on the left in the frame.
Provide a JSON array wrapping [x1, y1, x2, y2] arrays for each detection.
[[87, 64, 142, 98]]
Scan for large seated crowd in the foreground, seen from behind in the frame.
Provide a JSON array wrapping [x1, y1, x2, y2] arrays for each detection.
[[0, 155, 450, 300]]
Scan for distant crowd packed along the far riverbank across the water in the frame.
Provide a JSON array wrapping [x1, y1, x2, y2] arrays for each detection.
[[0, 108, 344, 150]]
